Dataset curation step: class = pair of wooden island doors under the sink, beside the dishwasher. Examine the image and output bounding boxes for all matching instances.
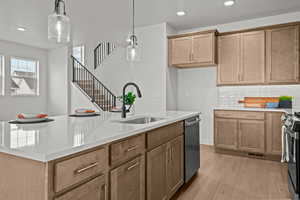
[147,136,183,200]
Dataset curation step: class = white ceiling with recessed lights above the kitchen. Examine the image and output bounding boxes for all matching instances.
[0,0,300,49]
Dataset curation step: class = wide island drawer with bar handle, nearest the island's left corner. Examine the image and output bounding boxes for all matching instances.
[54,147,108,192]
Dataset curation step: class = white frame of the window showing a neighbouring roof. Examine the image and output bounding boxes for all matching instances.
[8,56,40,97]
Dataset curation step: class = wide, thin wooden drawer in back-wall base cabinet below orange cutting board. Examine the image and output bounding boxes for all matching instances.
[215,111,265,120]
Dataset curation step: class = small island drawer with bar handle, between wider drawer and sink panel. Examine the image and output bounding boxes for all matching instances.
[110,134,145,165]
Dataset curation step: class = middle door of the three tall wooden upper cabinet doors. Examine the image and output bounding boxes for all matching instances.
[240,31,266,84]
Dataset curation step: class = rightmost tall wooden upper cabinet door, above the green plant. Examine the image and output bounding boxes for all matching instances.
[267,26,299,83]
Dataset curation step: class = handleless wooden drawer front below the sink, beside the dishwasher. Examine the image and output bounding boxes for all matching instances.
[147,122,184,149]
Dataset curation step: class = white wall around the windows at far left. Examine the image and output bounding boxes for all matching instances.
[0,40,48,120]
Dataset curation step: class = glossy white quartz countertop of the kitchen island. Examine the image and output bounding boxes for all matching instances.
[0,111,200,162]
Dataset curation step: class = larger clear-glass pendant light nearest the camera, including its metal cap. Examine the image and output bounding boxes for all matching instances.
[48,0,71,43]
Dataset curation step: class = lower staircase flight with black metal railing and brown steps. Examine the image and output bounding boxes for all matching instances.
[71,56,117,111]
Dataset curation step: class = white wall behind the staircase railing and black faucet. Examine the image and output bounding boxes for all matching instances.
[72,23,167,113]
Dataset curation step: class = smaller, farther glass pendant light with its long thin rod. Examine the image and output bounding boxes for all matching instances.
[127,0,140,62]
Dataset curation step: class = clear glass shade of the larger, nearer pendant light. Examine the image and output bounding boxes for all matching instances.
[48,12,71,43]
